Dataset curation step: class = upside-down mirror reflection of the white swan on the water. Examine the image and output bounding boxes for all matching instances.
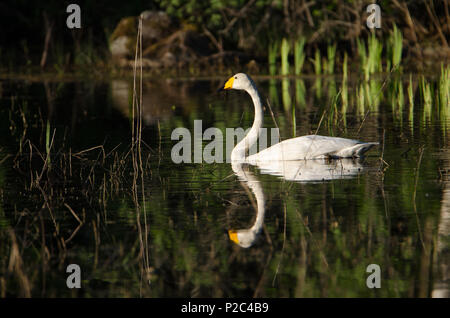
[228,159,372,248]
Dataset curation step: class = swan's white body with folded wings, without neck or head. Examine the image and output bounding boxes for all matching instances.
[248,135,377,163]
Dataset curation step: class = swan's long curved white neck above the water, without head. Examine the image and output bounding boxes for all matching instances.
[231,83,264,161]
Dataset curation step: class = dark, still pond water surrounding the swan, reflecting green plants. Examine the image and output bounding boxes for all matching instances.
[0,78,450,297]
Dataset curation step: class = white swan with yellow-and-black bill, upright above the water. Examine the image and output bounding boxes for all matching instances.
[219,73,379,165]
